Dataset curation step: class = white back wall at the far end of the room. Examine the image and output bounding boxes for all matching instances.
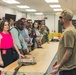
[27,14,59,32]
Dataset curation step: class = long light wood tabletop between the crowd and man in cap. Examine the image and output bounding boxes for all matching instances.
[2,42,58,75]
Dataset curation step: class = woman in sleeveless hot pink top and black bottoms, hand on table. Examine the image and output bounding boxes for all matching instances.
[0,20,24,68]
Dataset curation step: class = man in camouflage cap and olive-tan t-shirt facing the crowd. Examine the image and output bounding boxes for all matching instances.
[51,9,76,75]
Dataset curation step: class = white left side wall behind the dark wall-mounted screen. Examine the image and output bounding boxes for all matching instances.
[0,6,26,20]
